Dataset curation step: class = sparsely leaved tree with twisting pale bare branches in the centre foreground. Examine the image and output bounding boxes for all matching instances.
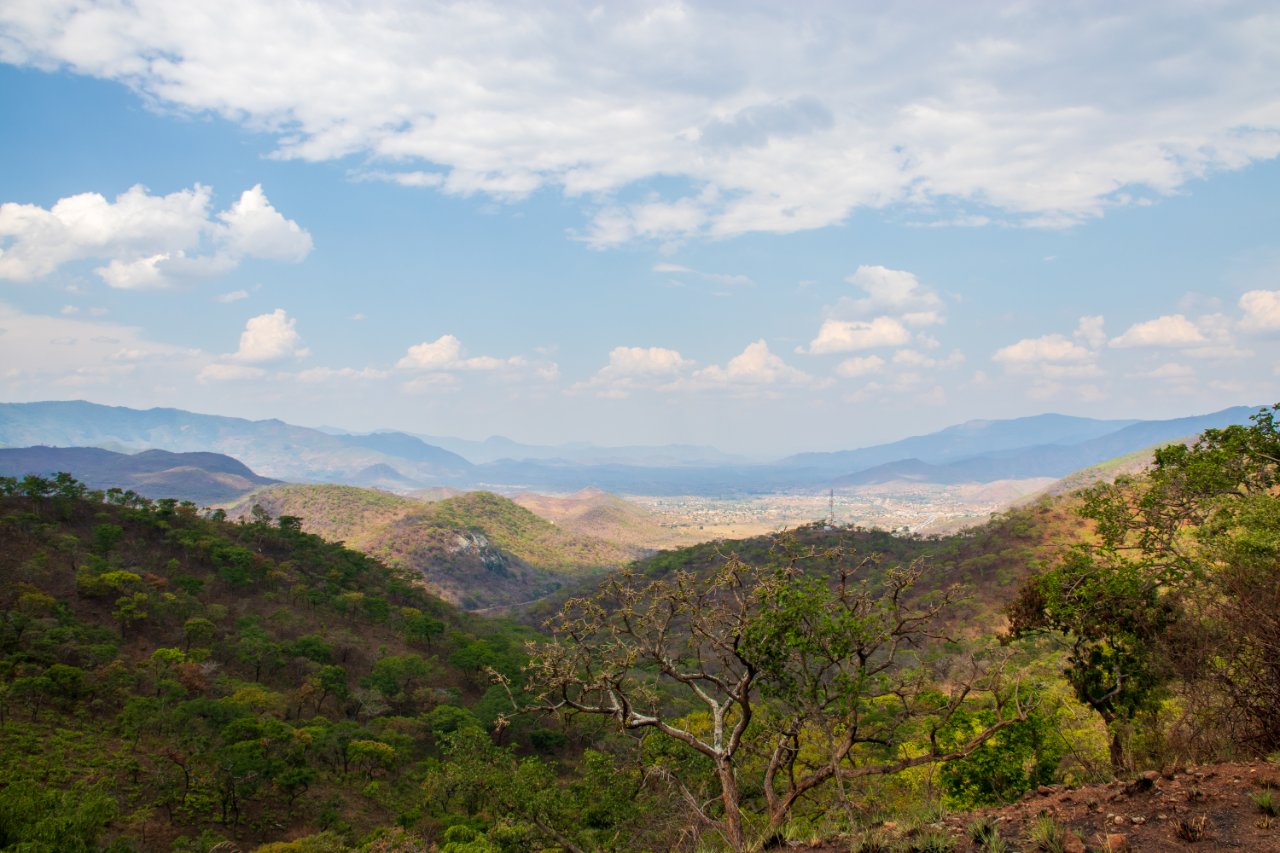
[527,552,1029,850]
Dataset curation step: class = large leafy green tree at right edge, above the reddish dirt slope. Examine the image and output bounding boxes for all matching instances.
[1010,406,1280,758]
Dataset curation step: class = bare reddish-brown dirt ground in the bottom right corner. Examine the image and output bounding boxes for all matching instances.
[817,761,1280,853]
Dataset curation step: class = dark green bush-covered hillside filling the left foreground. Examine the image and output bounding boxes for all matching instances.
[0,479,547,852]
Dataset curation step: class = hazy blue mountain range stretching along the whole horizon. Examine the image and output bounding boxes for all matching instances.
[0,401,1256,494]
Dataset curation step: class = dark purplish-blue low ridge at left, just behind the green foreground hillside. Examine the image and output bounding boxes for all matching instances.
[0,446,279,505]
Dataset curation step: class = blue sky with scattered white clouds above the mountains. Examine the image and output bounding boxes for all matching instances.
[0,0,1280,457]
